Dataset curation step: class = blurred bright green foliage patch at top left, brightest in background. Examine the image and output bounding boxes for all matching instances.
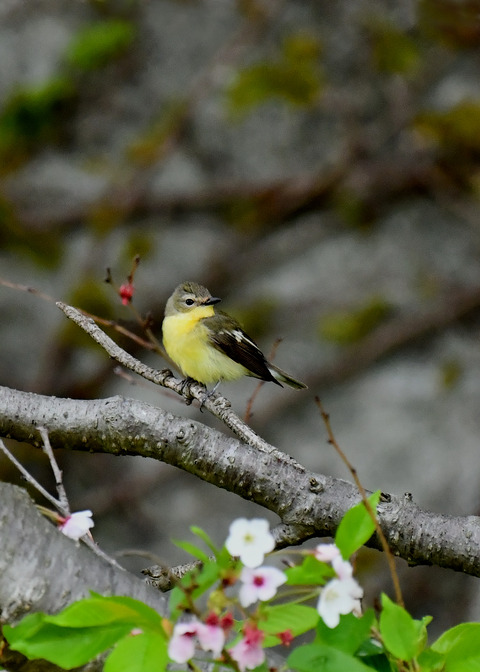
[66,19,136,72]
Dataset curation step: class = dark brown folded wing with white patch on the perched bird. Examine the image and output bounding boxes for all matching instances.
[204,313,283,387]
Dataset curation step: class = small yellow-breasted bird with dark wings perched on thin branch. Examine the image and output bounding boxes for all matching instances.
[162,282,307,393]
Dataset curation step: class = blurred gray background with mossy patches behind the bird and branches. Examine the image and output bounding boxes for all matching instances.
[0,0,480,633]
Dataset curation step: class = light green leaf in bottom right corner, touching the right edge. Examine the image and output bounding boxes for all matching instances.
[431,623,480,672]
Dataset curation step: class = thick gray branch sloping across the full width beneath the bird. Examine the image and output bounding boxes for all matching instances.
[0,388,480,576]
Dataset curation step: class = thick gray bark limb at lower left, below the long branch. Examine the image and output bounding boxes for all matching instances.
[0,483,167,623]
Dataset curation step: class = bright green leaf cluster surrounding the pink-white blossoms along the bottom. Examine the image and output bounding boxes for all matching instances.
[4,492,480,672]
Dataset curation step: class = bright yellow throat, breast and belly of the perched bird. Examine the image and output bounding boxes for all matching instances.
[163,314,248,385]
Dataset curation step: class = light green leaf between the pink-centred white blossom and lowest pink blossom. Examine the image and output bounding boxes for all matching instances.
[259,603,320,646]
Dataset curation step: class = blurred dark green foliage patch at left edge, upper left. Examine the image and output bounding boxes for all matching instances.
[0,77,76,172]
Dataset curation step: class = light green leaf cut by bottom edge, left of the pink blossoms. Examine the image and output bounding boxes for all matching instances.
[104,632,168,672]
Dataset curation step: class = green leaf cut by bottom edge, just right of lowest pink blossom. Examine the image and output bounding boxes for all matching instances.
[287,644,374,672]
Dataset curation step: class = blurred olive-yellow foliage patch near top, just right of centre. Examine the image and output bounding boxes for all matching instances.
[227,34,323,118]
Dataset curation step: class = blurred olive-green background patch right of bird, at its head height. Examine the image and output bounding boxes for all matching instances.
[319,296,392,345]
